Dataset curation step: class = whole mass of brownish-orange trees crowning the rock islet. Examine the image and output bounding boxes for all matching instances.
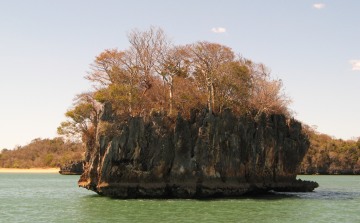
[58,27,290,143]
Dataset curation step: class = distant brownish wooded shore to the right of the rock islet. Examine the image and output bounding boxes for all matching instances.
[300,126,360,174]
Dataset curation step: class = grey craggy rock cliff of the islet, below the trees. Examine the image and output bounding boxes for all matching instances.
[79,106,318,198]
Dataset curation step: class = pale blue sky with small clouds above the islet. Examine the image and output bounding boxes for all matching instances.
[0,0,360,149]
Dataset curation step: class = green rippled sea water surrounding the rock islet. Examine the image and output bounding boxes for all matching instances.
[0,173,360,223]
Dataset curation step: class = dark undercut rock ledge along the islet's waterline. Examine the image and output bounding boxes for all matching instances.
[79,181,319,199]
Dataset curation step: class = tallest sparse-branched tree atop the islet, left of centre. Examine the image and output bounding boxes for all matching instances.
[86,27,169,116]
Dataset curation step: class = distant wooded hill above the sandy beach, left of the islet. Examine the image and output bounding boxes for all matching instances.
[0,138,84,168]
